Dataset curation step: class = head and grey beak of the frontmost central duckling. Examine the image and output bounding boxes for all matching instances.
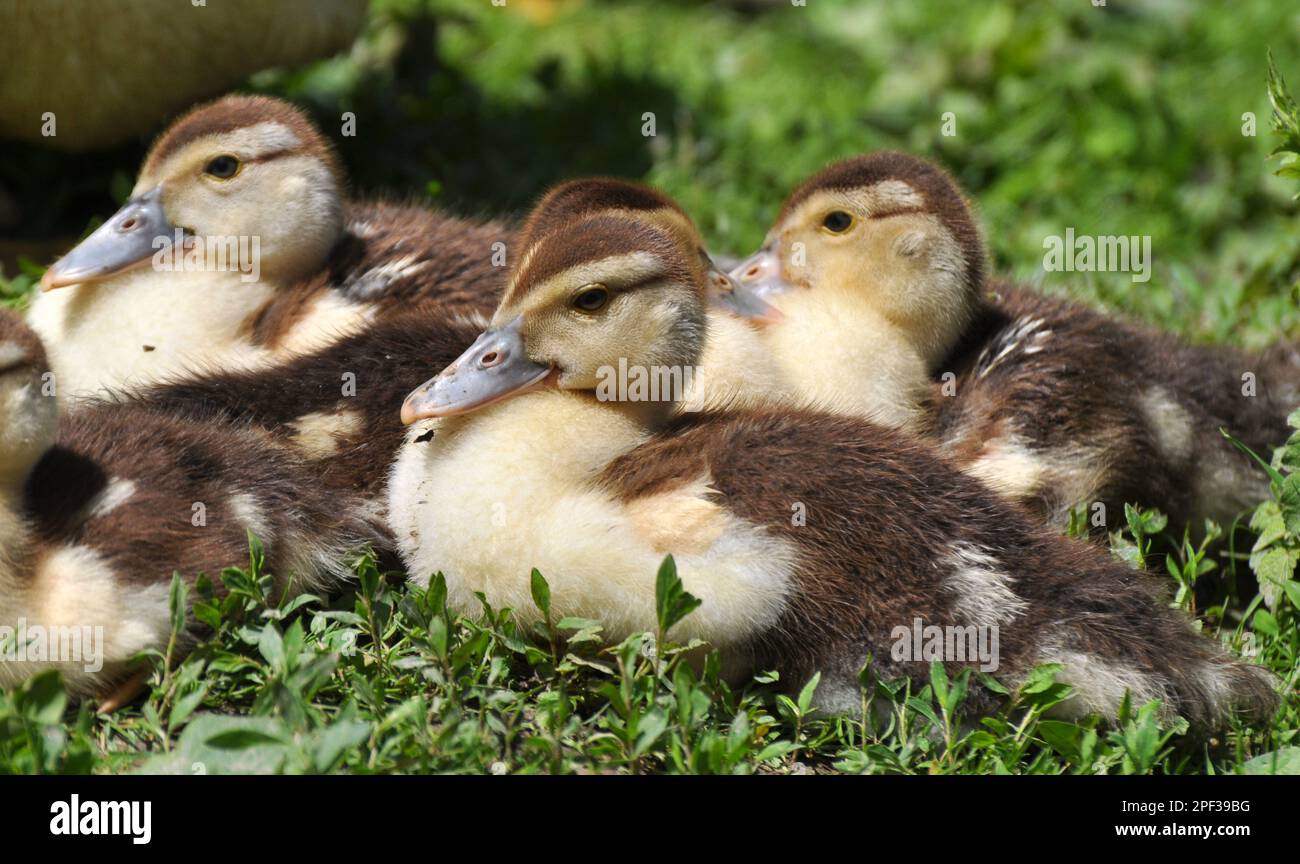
[402,200,707,424]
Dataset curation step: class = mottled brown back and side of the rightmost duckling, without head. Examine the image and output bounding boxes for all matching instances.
[931,285,1287,529]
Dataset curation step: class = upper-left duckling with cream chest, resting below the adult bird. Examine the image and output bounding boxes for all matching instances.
[29,96,508,398]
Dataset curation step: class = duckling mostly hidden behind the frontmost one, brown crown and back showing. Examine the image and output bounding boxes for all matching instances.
[127,178,785,548]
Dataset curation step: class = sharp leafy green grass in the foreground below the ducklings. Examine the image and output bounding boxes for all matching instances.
[0,547,1300,774]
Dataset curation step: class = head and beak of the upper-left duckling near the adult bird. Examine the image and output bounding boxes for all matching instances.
[42,96,345,291]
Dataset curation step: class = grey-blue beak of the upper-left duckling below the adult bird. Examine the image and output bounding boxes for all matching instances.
[40,183,177,291]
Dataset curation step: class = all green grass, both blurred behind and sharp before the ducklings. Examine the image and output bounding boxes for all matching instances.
[0,0,1300,773]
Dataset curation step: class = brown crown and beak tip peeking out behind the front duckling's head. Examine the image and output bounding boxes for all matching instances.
[520,177,780,322]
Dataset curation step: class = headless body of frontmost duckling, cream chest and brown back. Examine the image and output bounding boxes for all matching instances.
[389,392,1275,729]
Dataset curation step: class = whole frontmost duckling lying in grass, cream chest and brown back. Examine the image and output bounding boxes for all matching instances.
[389,198,1275,728]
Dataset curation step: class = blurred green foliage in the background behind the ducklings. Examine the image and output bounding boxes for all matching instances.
[0,0,1300,346]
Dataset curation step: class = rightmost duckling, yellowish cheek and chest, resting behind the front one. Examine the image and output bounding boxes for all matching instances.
[732,152,1294,530]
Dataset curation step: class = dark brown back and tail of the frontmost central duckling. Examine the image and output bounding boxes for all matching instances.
[602,412,1277,729]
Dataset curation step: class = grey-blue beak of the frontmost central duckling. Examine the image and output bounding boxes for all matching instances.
[402,318,554,426]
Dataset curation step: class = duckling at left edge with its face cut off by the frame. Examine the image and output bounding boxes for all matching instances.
[0,311,381,696]
